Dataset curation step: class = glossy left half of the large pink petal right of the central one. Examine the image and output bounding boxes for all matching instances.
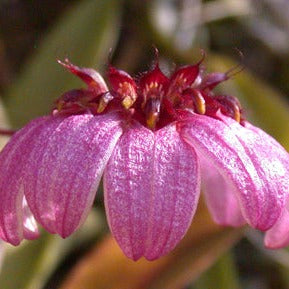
[179,114,264,229]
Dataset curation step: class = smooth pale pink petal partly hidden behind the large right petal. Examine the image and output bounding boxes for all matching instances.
[201,154,246,227]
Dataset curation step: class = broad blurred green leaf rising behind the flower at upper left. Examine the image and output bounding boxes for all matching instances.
[5,0,120,127]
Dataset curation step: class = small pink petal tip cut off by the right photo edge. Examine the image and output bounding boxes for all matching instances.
[264,209,289,249]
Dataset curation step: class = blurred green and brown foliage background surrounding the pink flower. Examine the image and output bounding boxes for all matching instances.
[0,0,289,289]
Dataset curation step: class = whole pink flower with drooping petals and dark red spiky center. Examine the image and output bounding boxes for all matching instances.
[0,50,289,260]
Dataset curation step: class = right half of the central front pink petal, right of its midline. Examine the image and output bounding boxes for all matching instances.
[144,125,200,260]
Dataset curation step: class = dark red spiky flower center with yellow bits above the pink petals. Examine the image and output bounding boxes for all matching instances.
[54,53,243,130]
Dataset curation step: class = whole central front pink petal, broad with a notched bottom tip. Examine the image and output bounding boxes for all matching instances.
[104,125,200,260]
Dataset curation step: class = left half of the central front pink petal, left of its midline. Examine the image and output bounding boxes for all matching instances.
[103,125,154,260]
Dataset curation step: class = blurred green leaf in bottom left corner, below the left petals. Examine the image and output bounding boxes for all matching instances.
[0,210,103,289]
